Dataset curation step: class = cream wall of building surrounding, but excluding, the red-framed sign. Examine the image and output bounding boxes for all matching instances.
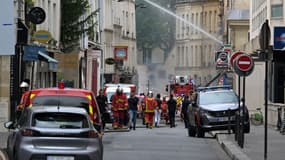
[102,0,137,82]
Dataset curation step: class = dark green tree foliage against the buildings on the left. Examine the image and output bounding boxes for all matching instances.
[60,0,98,52]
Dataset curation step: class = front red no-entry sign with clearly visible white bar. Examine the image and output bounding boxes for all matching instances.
[236,54,253,72]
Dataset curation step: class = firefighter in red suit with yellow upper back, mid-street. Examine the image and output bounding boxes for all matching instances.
[145,92,157,129]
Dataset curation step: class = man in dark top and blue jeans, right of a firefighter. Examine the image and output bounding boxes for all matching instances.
[128,92,139,130]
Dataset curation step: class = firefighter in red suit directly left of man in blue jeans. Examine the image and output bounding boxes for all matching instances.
[112,88,128,129]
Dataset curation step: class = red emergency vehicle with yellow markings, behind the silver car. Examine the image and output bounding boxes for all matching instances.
[17,84,102,131]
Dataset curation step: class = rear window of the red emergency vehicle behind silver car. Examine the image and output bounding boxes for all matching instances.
[32,96,89,109]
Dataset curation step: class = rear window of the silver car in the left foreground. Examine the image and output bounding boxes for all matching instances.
[32,112,89,129]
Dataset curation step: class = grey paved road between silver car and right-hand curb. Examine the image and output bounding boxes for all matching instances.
[103,122,229,160]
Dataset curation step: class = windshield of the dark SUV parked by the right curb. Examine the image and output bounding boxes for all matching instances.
[199,92,238,105]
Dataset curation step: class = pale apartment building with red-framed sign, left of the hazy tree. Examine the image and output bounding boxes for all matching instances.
[100,0,137,83]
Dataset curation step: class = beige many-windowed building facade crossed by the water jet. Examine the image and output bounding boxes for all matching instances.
[175,0,222,85]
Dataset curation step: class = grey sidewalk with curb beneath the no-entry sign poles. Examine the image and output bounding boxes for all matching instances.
[216,125,285,160]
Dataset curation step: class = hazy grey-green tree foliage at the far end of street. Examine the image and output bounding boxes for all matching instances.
[136,0,175,55]
